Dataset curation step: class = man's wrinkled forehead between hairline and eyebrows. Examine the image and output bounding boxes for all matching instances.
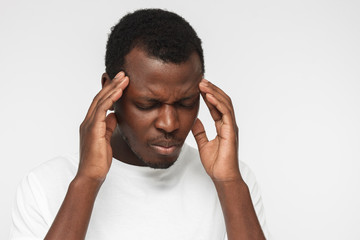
[124,48,203,101]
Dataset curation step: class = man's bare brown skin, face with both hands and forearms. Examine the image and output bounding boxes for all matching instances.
[45,48,265,240]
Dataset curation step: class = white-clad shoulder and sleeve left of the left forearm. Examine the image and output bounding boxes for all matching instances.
[12,155,77,232]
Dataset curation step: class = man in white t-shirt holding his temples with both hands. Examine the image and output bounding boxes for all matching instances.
[11,9,265,240]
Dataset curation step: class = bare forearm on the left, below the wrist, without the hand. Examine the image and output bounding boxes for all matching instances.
[45,175,102,240]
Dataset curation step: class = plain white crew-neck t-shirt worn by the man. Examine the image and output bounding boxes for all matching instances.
[10,145,267,240]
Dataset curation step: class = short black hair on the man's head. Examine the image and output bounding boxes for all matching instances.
[105,9,205,79]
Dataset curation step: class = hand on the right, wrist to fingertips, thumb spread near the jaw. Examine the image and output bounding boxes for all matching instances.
[192,79,242,181]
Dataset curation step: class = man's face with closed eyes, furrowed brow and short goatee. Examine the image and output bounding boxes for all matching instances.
[115,48,203,168]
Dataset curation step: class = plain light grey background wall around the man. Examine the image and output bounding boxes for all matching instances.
[0,0,360,240]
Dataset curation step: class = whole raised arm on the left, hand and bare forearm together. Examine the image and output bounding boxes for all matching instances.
[45,72,129,240]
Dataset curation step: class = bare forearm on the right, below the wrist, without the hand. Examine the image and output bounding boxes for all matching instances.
[214,179,265,240]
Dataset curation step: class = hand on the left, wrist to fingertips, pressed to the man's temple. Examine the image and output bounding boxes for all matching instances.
[76,72,129,183]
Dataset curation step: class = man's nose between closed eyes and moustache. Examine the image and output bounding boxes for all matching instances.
[155,104,180,133]
